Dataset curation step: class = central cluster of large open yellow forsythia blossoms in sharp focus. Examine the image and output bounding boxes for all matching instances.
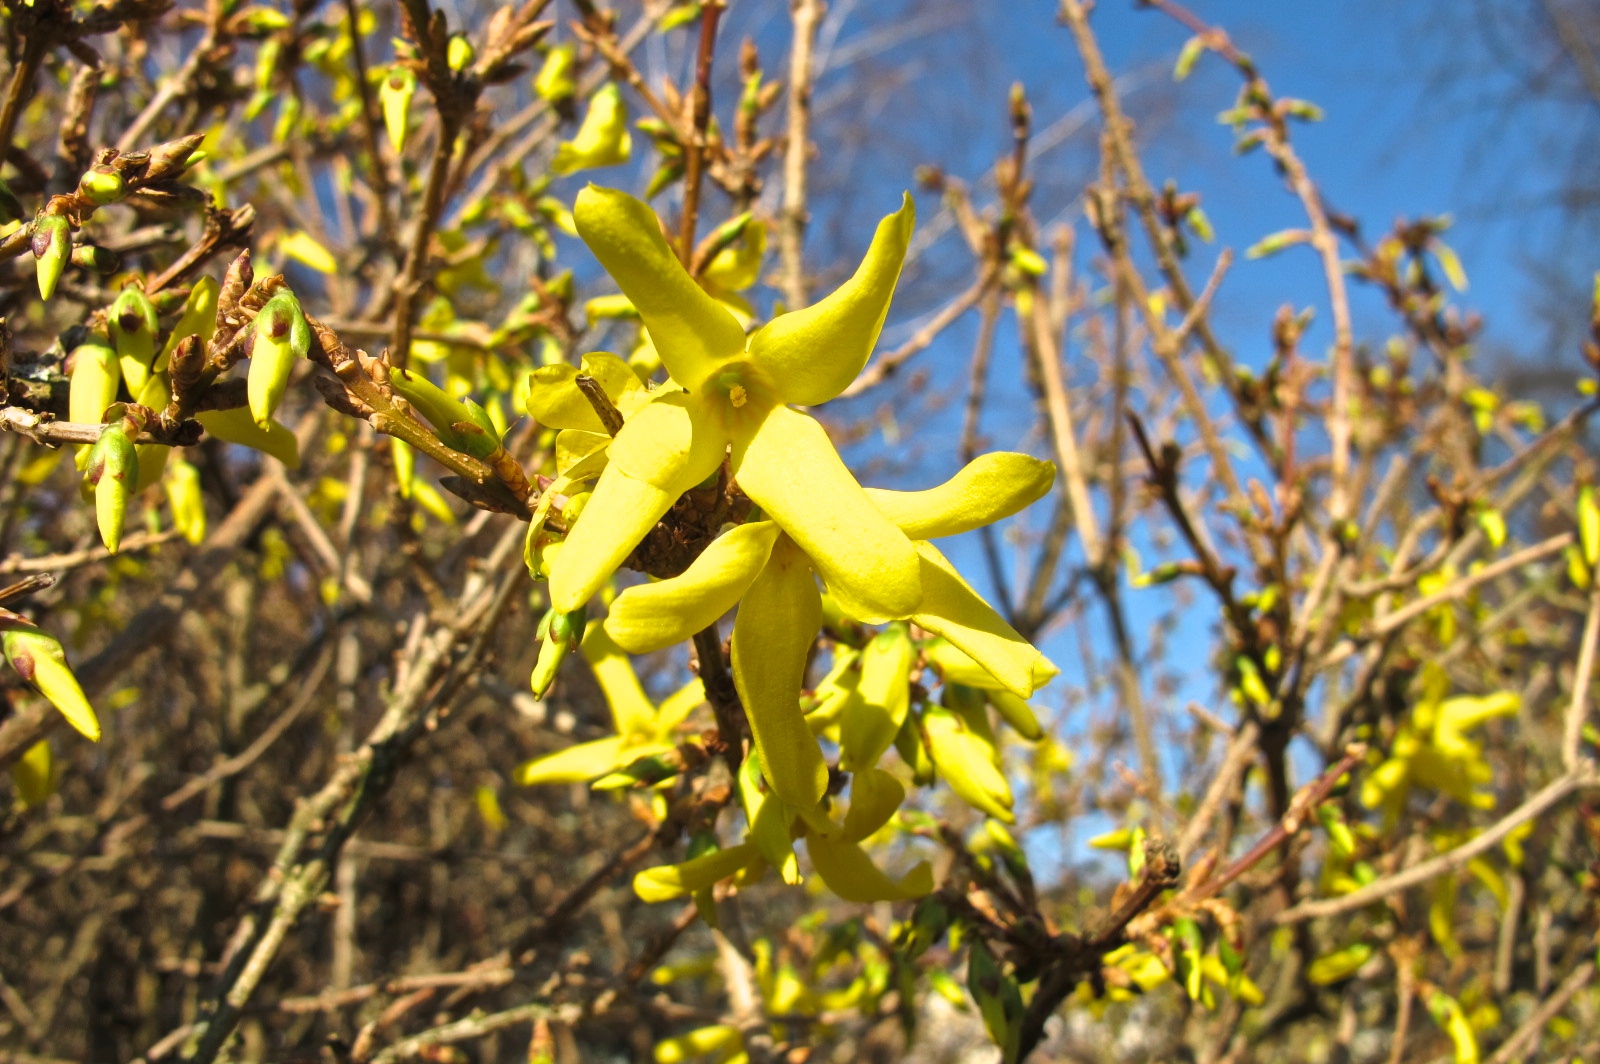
[528,186,1056,899]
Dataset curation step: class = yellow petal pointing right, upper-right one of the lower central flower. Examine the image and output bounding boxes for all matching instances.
[866,451,1056,539]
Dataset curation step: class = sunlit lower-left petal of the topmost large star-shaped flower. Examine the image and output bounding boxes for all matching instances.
[550,392,726,613]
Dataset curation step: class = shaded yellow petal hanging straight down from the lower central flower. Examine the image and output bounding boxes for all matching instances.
[733,539,827,810]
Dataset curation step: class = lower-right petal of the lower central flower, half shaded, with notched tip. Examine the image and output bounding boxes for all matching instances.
[912,542,1056,698]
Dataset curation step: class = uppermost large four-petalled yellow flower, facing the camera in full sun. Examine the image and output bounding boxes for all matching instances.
[550,186,925,630]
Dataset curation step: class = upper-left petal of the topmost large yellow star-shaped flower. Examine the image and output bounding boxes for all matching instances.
[573,186,744,392]
